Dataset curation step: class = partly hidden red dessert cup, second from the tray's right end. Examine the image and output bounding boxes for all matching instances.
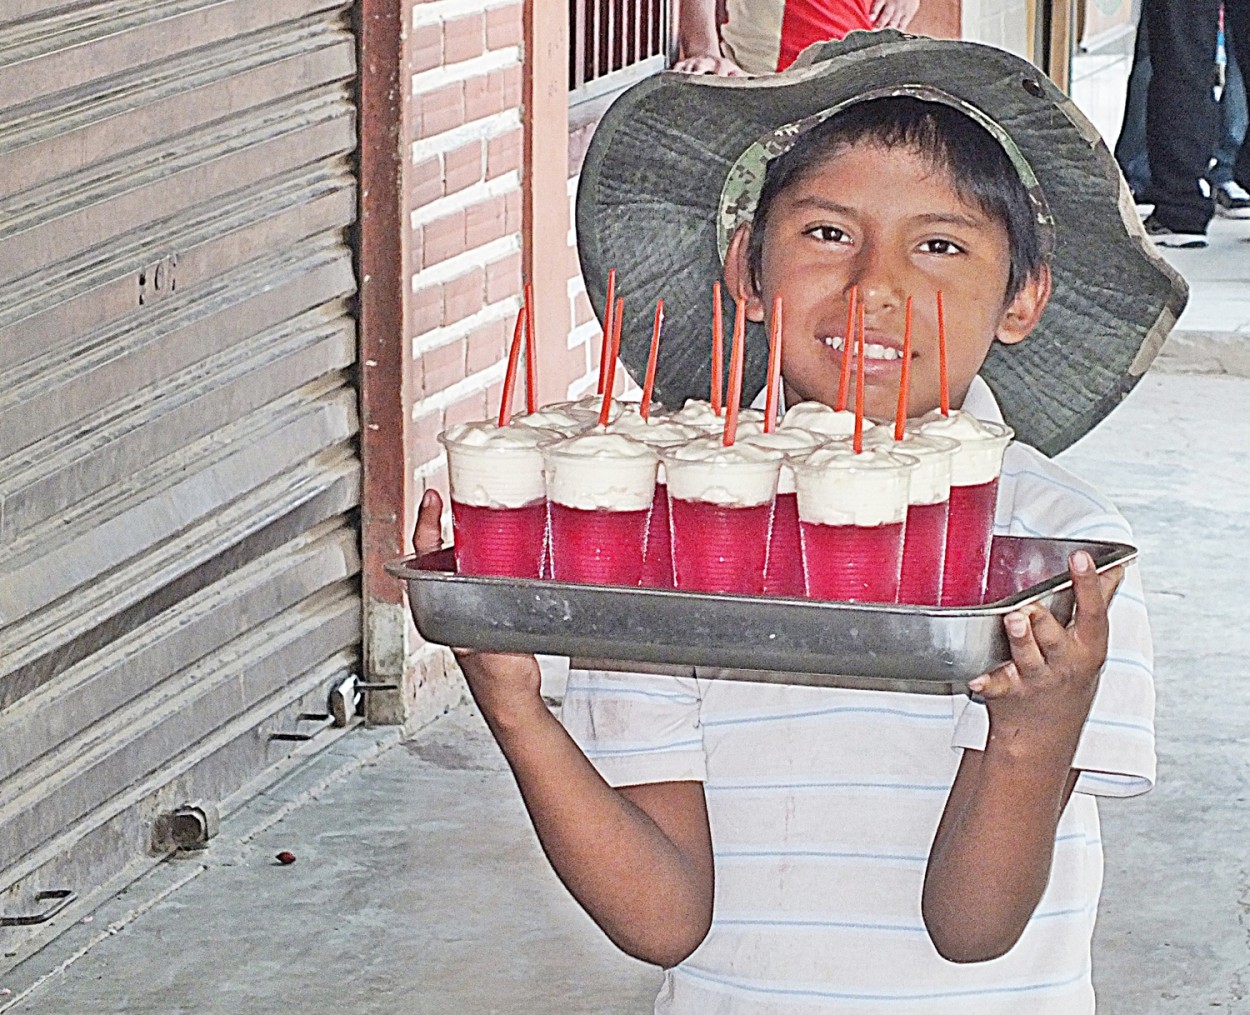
[864,426,959,606]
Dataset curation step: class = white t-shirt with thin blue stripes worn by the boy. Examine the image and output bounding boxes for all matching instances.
[564,381,1155,1015]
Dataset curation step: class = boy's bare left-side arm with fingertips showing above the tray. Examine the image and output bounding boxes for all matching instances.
[413,493,713,968]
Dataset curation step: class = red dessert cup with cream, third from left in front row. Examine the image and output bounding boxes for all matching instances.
[661,435,781,595]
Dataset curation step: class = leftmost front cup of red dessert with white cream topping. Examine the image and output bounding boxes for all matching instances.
[439,421,555,578]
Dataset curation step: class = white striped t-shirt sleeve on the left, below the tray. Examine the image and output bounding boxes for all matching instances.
[560,670,708,786]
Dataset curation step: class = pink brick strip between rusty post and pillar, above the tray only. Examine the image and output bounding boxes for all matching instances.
[408,0,524,515]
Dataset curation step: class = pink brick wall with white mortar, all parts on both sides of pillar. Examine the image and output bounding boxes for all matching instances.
[390,0,615,724]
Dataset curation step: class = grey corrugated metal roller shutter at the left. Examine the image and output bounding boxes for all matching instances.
[0,0,361,950]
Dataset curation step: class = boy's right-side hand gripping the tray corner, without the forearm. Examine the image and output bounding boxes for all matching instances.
[968,551,1124,744]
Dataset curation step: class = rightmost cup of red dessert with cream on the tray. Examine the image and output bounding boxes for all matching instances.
[916,410,1014,606]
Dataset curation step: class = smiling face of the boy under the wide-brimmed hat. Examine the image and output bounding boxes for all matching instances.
[725,145,1050,418]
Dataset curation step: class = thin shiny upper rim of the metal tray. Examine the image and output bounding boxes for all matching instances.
[383,535,1139,619]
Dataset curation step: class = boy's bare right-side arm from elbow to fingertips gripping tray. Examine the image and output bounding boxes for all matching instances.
[923,554,1121,963]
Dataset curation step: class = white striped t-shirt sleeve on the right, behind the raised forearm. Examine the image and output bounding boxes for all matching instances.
[954,516,1155,796]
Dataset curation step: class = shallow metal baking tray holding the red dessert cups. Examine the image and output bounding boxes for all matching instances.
[386,536,1138,686]
